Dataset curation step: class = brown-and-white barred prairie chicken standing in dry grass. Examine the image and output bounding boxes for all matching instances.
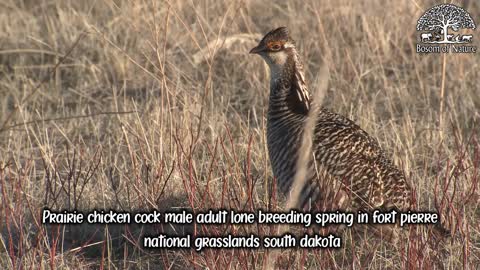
[250,27,412,211]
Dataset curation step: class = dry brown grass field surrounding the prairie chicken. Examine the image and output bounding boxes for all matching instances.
[0,0,480,269]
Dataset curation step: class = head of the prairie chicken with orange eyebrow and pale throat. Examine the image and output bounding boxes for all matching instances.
[250,27,295,70]
